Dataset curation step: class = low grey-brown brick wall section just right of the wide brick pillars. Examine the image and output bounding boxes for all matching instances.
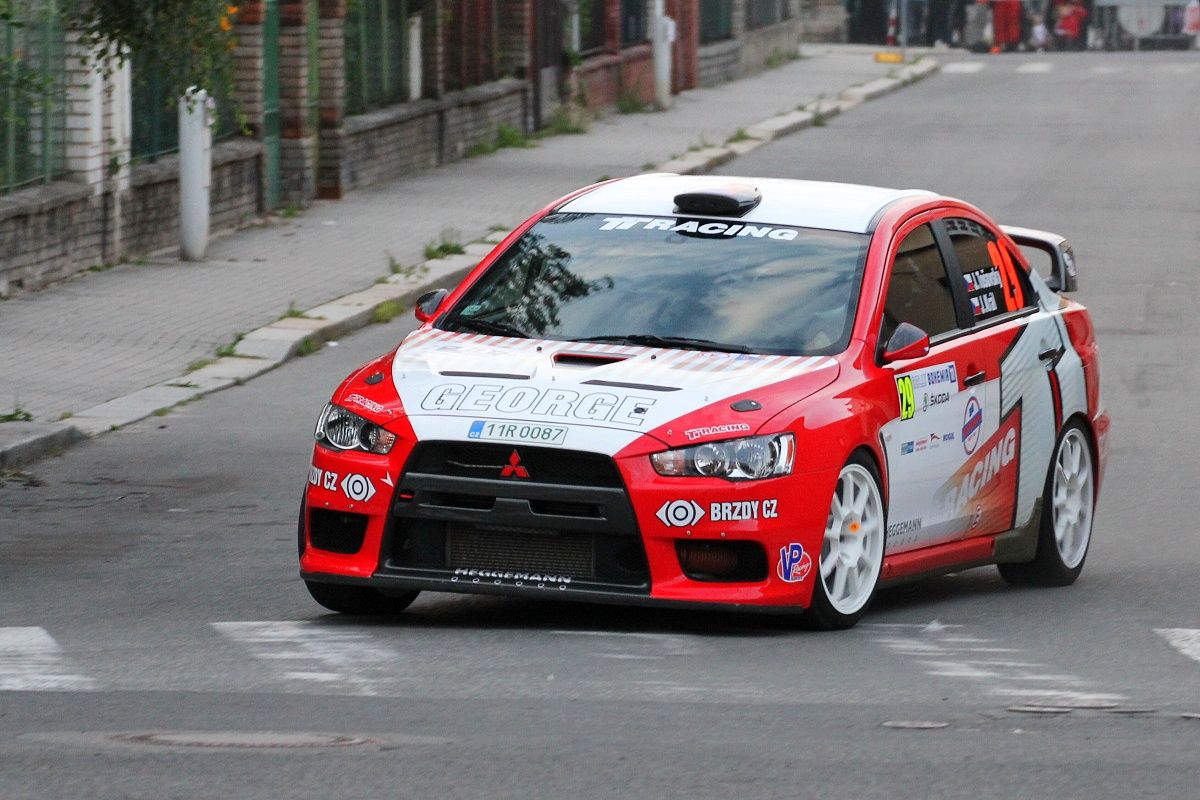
[338,78,529,191]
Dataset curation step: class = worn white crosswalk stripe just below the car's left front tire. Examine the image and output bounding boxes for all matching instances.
[211,621,403,696]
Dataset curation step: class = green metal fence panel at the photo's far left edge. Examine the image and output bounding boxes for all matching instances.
[0,0,67,194]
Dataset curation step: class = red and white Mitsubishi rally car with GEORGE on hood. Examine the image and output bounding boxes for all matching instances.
[299,175,1109,628]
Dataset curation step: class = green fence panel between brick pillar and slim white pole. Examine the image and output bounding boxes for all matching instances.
[346,0,409,114]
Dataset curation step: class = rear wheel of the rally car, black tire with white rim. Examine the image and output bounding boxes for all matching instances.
[996,422,1096,587]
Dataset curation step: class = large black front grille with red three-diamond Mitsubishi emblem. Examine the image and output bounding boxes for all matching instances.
[379,443,649,594]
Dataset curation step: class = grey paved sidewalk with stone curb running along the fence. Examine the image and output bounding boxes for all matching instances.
[0,44,936,468]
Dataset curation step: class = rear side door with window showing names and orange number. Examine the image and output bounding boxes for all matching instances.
[937,216,1063,536]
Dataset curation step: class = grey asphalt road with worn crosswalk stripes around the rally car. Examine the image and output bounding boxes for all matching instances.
[0,53,1200,800]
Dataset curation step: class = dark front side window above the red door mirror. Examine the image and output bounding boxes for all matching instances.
[880,225,958,342]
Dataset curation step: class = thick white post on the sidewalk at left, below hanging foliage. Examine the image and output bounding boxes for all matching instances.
[179,86,214,261]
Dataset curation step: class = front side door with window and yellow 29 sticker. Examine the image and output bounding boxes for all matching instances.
[880,222,986,553]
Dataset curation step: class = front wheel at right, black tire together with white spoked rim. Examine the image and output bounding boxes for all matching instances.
[804,453,887,631]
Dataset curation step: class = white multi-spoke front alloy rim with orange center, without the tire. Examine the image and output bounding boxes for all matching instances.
[818,462,886,615]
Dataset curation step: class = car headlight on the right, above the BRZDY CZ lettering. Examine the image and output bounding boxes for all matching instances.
[650,433,796,481]
